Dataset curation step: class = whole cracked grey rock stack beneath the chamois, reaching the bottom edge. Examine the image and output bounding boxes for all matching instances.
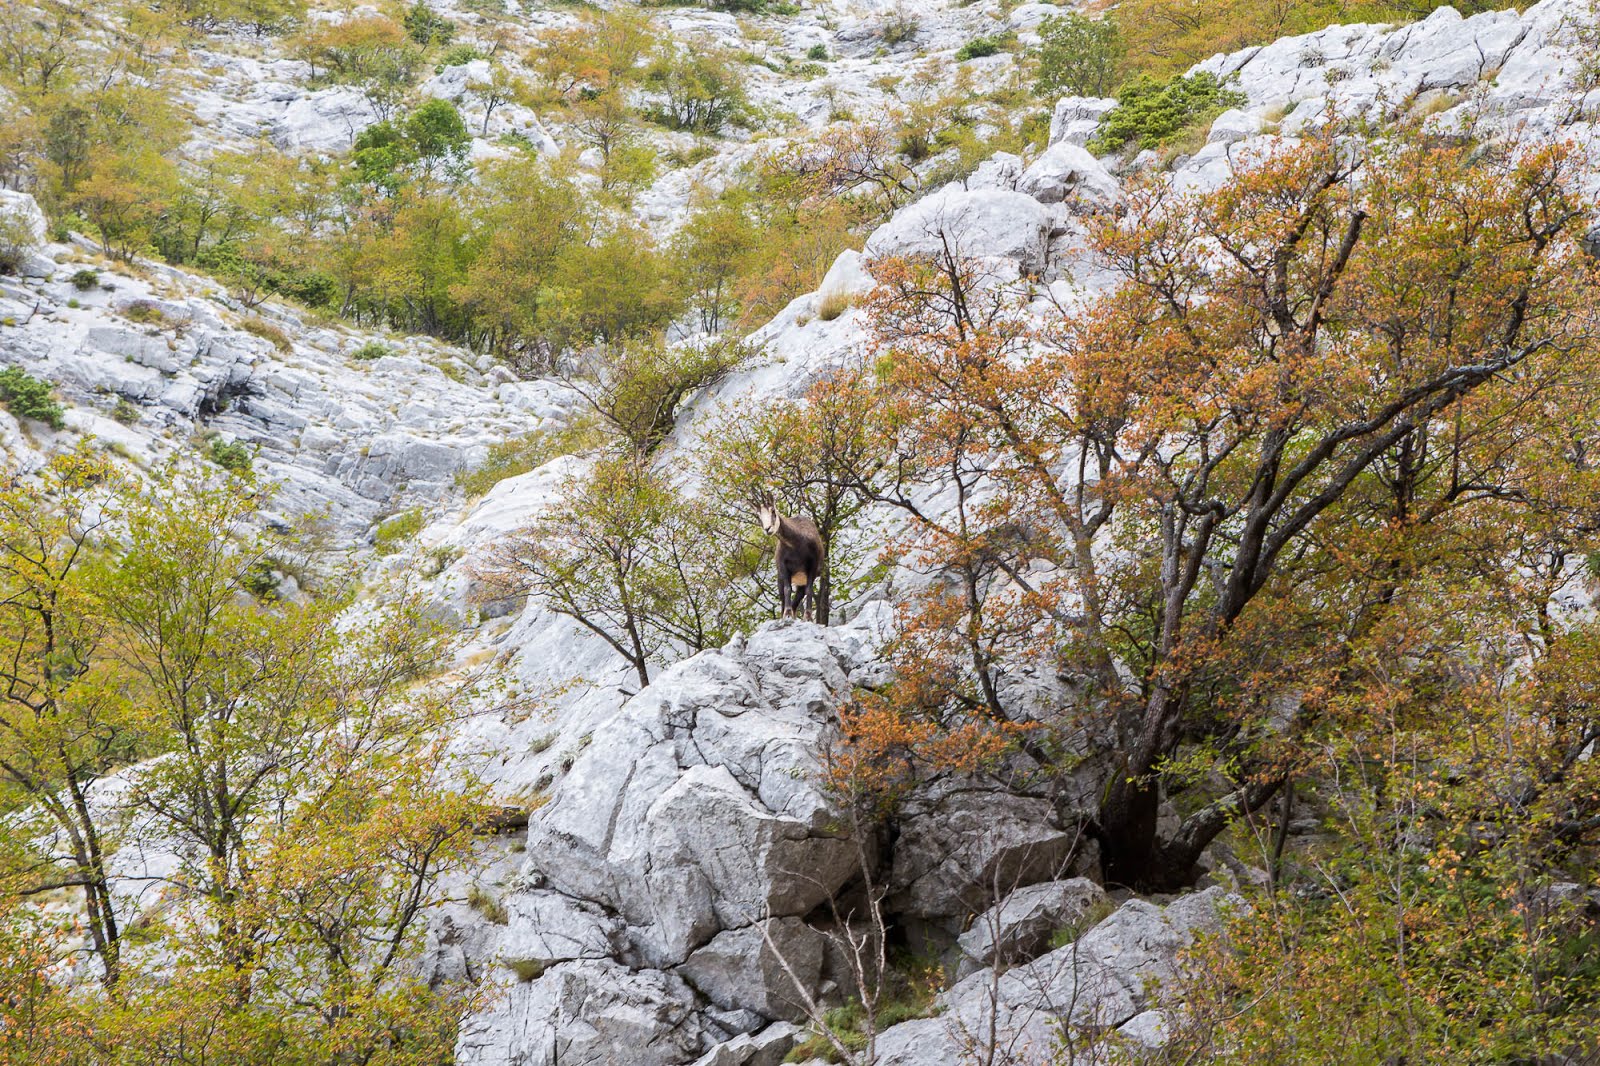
[459,603,890,1066]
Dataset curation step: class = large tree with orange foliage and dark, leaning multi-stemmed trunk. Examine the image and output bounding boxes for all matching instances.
[844,128,1597,888]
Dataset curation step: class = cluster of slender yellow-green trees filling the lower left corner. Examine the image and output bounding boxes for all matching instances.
[0,453,482,1066]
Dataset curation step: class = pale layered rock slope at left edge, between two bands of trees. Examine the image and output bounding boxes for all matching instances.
[0,228,574,541]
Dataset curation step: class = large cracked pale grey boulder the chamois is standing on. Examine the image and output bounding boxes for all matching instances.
[525,607,888,967]
